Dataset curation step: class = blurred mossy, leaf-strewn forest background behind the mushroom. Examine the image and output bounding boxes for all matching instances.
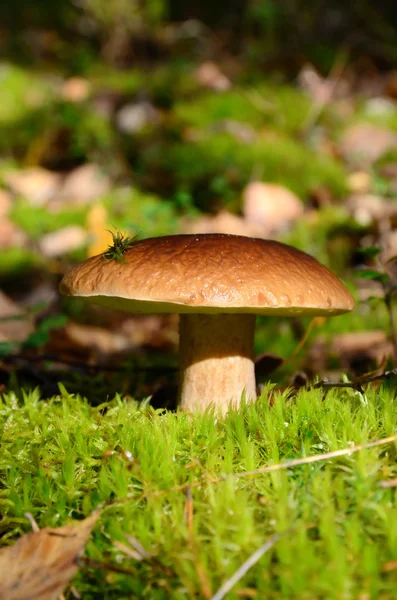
[0,0,397,404]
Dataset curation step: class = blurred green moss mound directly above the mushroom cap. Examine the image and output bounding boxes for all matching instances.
[139,132,345,210]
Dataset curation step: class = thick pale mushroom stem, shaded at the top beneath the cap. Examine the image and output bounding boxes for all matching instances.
[179,313,256,413]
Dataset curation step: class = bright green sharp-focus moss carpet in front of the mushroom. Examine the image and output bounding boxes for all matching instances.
[0,385,397,599]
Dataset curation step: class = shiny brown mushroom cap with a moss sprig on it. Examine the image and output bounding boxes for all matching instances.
[60,234,354,315]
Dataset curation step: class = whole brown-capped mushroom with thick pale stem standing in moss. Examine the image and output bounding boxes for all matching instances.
[60,234,354,412]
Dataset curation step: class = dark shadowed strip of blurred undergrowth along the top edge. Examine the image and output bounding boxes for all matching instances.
[0,0,397,72]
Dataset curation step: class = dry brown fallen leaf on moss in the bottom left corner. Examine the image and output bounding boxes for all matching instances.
[0,513,99,600]
